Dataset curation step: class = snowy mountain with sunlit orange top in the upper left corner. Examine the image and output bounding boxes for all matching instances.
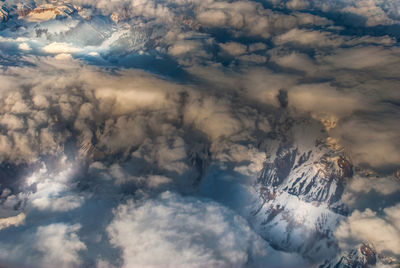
[0,1,159,56]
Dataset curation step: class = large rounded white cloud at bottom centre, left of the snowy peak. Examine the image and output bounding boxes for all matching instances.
[107,192,304,267]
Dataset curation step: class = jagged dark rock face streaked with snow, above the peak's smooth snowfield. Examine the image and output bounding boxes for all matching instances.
[258,144,352,205]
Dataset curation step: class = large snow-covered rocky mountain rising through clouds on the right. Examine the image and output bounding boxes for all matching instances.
[251,120,353,261]
